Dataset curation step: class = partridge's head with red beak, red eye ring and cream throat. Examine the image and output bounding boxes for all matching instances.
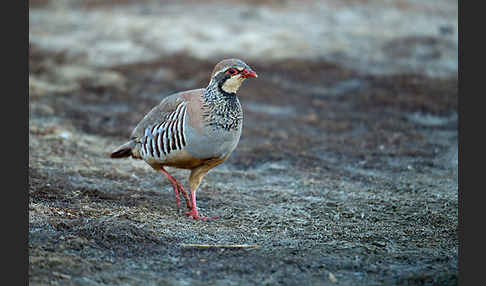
[210,59,258,93]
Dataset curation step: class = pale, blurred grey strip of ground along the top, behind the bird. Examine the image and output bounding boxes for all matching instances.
[29,0,458,76]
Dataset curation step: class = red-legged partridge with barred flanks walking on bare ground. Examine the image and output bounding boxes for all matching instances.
[110,58,258,221]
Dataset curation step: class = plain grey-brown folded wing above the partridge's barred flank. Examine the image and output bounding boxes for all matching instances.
[131,89,202,139]
